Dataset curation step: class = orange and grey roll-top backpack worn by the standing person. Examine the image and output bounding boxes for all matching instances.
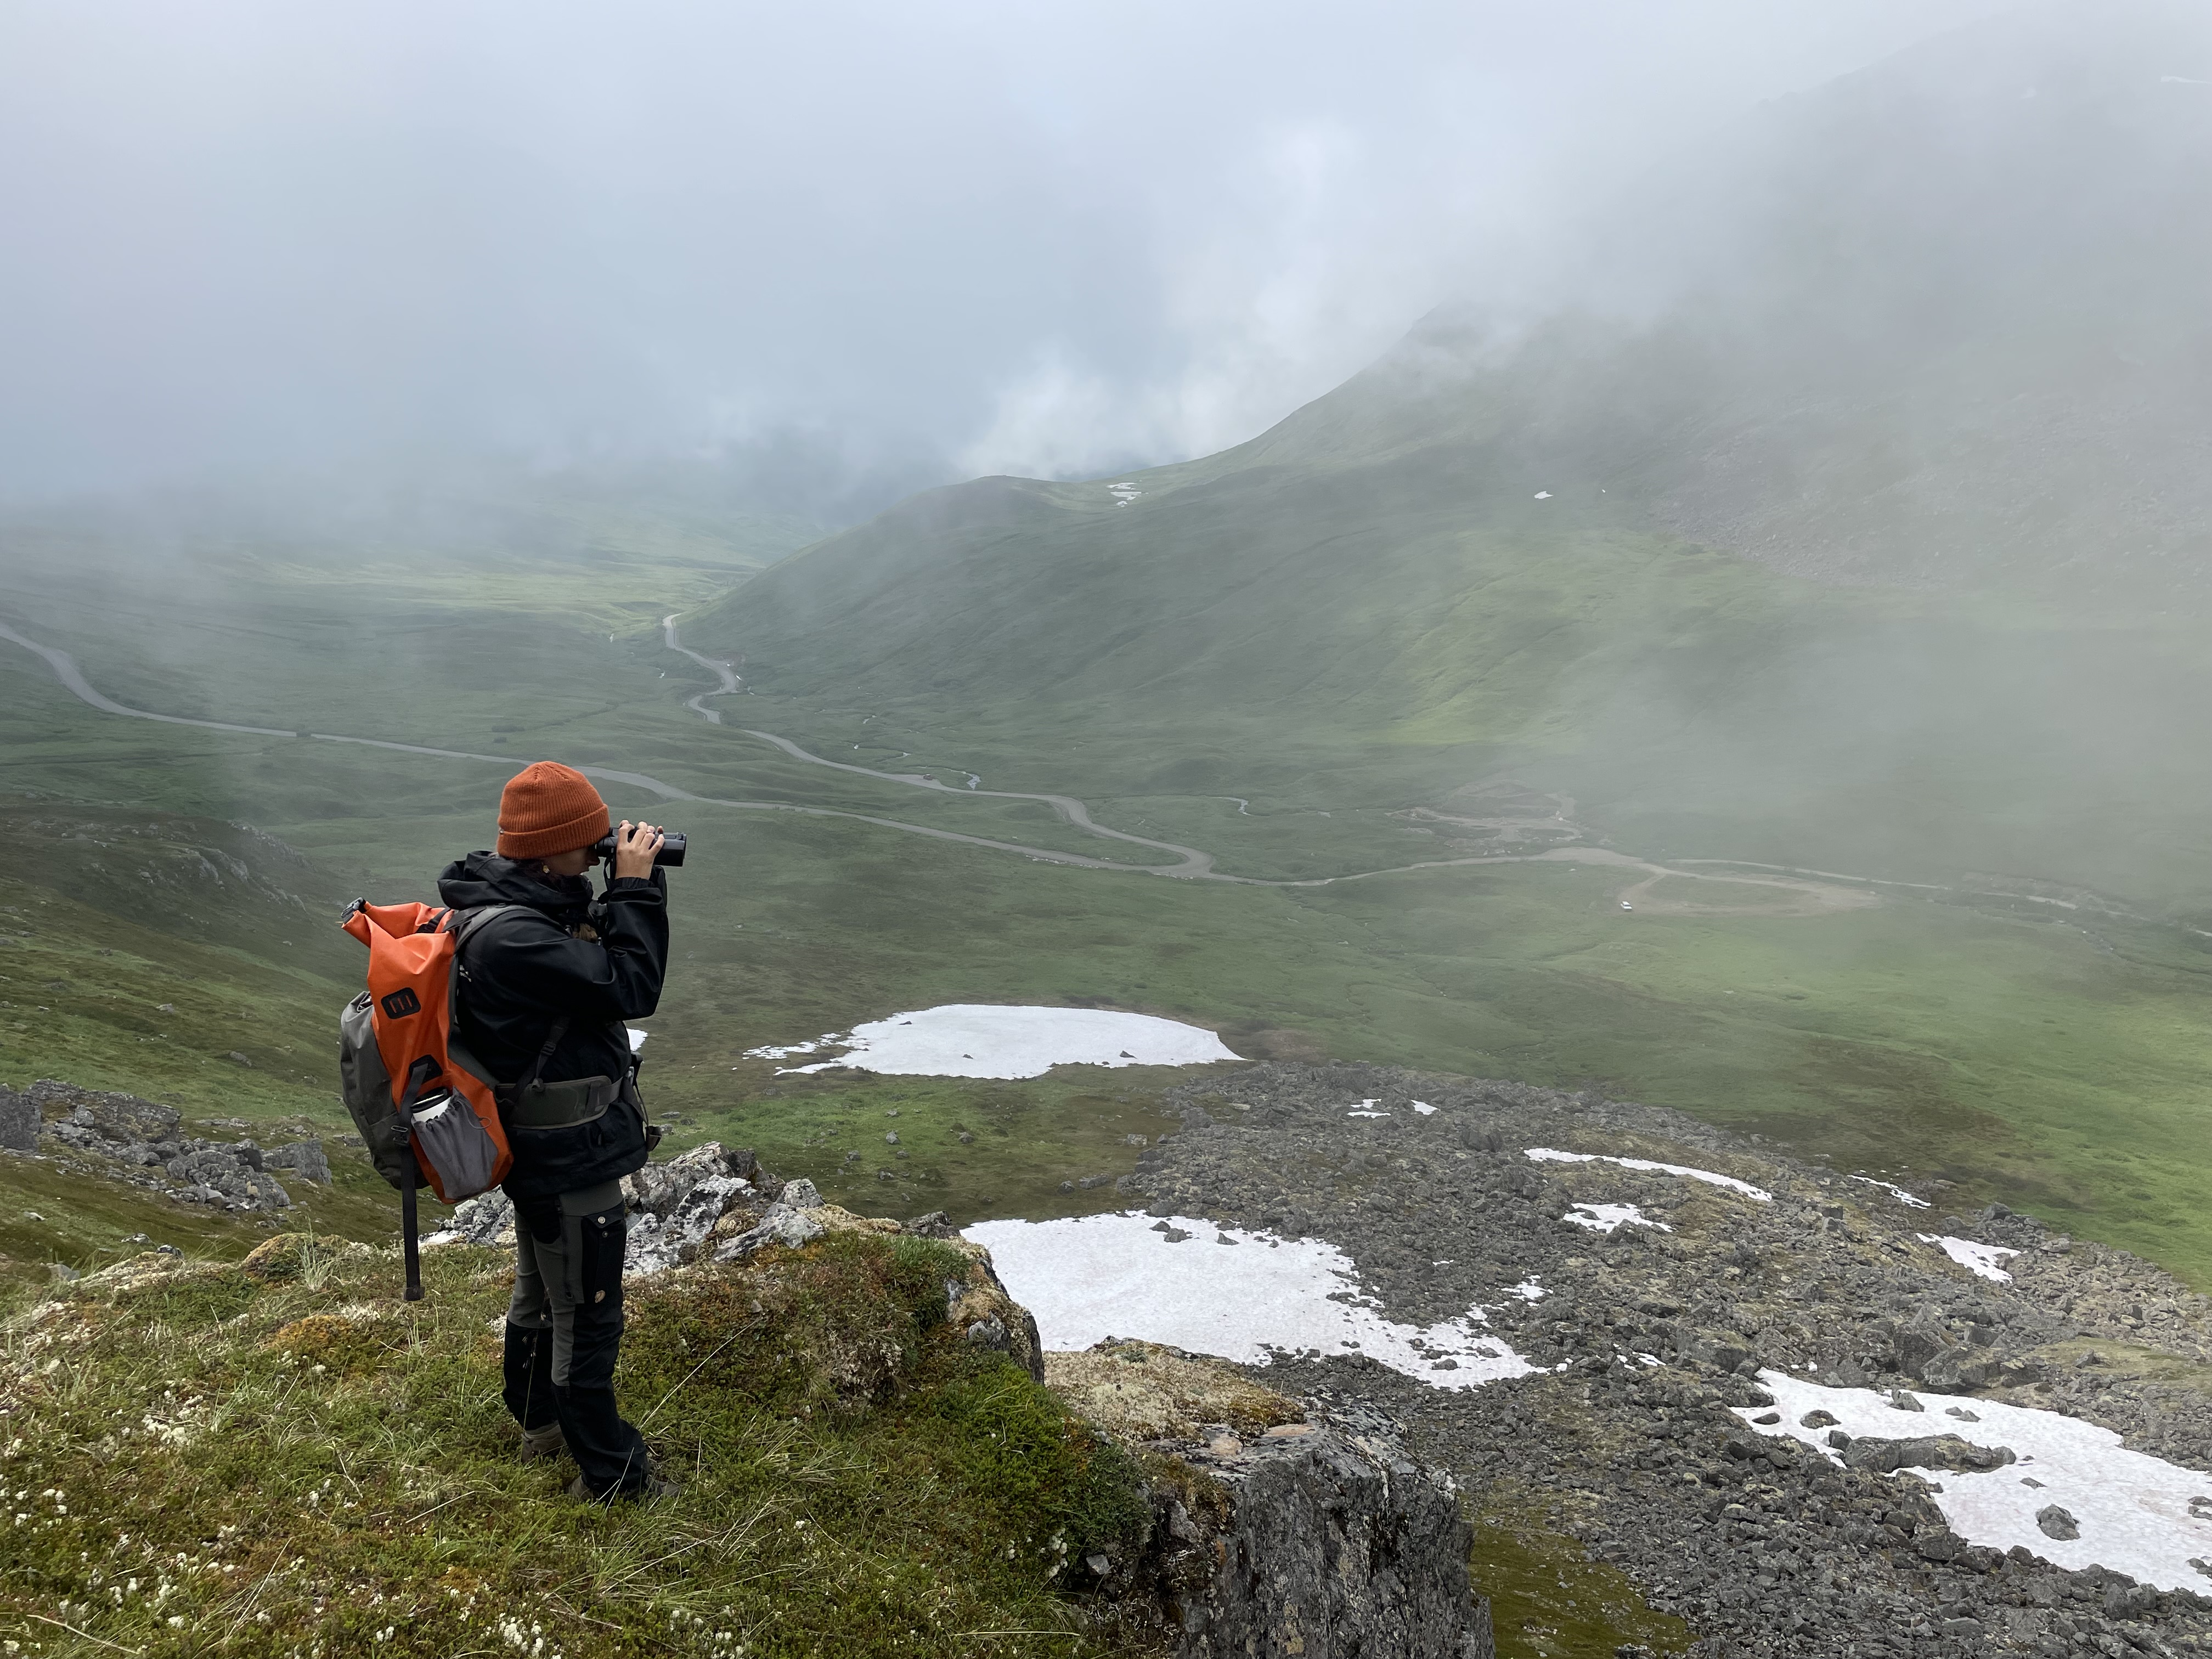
[338,898,522,1301]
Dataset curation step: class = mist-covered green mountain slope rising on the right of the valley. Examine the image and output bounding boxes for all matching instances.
[686,7,2212,911]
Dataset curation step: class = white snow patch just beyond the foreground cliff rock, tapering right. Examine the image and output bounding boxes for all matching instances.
[960,1215,1537,1389]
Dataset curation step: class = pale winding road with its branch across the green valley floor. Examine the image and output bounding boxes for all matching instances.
[0,613,2106,916]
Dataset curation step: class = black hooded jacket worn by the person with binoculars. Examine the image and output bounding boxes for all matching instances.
[438,851,668,1205]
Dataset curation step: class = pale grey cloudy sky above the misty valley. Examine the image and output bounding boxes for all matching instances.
[0,0,1993,498]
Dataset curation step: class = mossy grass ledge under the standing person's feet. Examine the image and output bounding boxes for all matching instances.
[0,1234,1144,1659]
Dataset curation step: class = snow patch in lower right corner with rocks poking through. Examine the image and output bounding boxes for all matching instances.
[1734,1372,2212,1590]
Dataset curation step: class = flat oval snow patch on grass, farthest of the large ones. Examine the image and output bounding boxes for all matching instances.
[746,1002,1241,1077]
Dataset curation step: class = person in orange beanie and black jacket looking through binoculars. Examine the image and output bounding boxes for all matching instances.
[438,761,677,1504]
